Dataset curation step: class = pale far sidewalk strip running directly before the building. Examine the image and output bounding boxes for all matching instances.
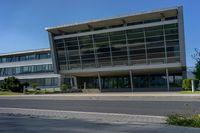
[0,92,200,101]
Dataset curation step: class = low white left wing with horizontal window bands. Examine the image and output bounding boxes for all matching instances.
[0,49,60,87]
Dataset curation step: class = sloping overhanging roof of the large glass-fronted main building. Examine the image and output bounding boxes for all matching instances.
[45,6,182,34]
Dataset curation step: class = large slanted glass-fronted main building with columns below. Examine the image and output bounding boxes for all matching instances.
[46,7,186,92]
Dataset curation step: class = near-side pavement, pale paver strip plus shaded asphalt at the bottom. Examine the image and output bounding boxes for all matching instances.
[0,108,200,133]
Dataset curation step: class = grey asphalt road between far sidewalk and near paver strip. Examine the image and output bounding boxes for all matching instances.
[0,98,200,116]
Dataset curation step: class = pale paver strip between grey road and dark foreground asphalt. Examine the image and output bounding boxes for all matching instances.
[0,108,167,124]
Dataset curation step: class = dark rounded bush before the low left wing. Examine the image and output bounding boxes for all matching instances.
[1,76,24,92]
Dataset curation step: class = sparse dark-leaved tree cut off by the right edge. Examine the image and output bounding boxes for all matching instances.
[192,48,200,80]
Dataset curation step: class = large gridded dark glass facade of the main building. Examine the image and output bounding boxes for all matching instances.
[55,23,180,70]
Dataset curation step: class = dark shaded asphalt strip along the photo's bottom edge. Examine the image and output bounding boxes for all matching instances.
[0,114,200,133]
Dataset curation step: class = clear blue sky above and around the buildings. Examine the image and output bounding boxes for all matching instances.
[0,0,200,66]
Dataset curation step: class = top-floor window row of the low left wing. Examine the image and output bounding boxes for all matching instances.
[0,53,51,63]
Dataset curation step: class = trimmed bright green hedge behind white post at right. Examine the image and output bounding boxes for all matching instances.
[182,78,199,91]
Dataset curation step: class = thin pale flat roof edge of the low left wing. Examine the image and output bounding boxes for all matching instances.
[0,48,50,56]
